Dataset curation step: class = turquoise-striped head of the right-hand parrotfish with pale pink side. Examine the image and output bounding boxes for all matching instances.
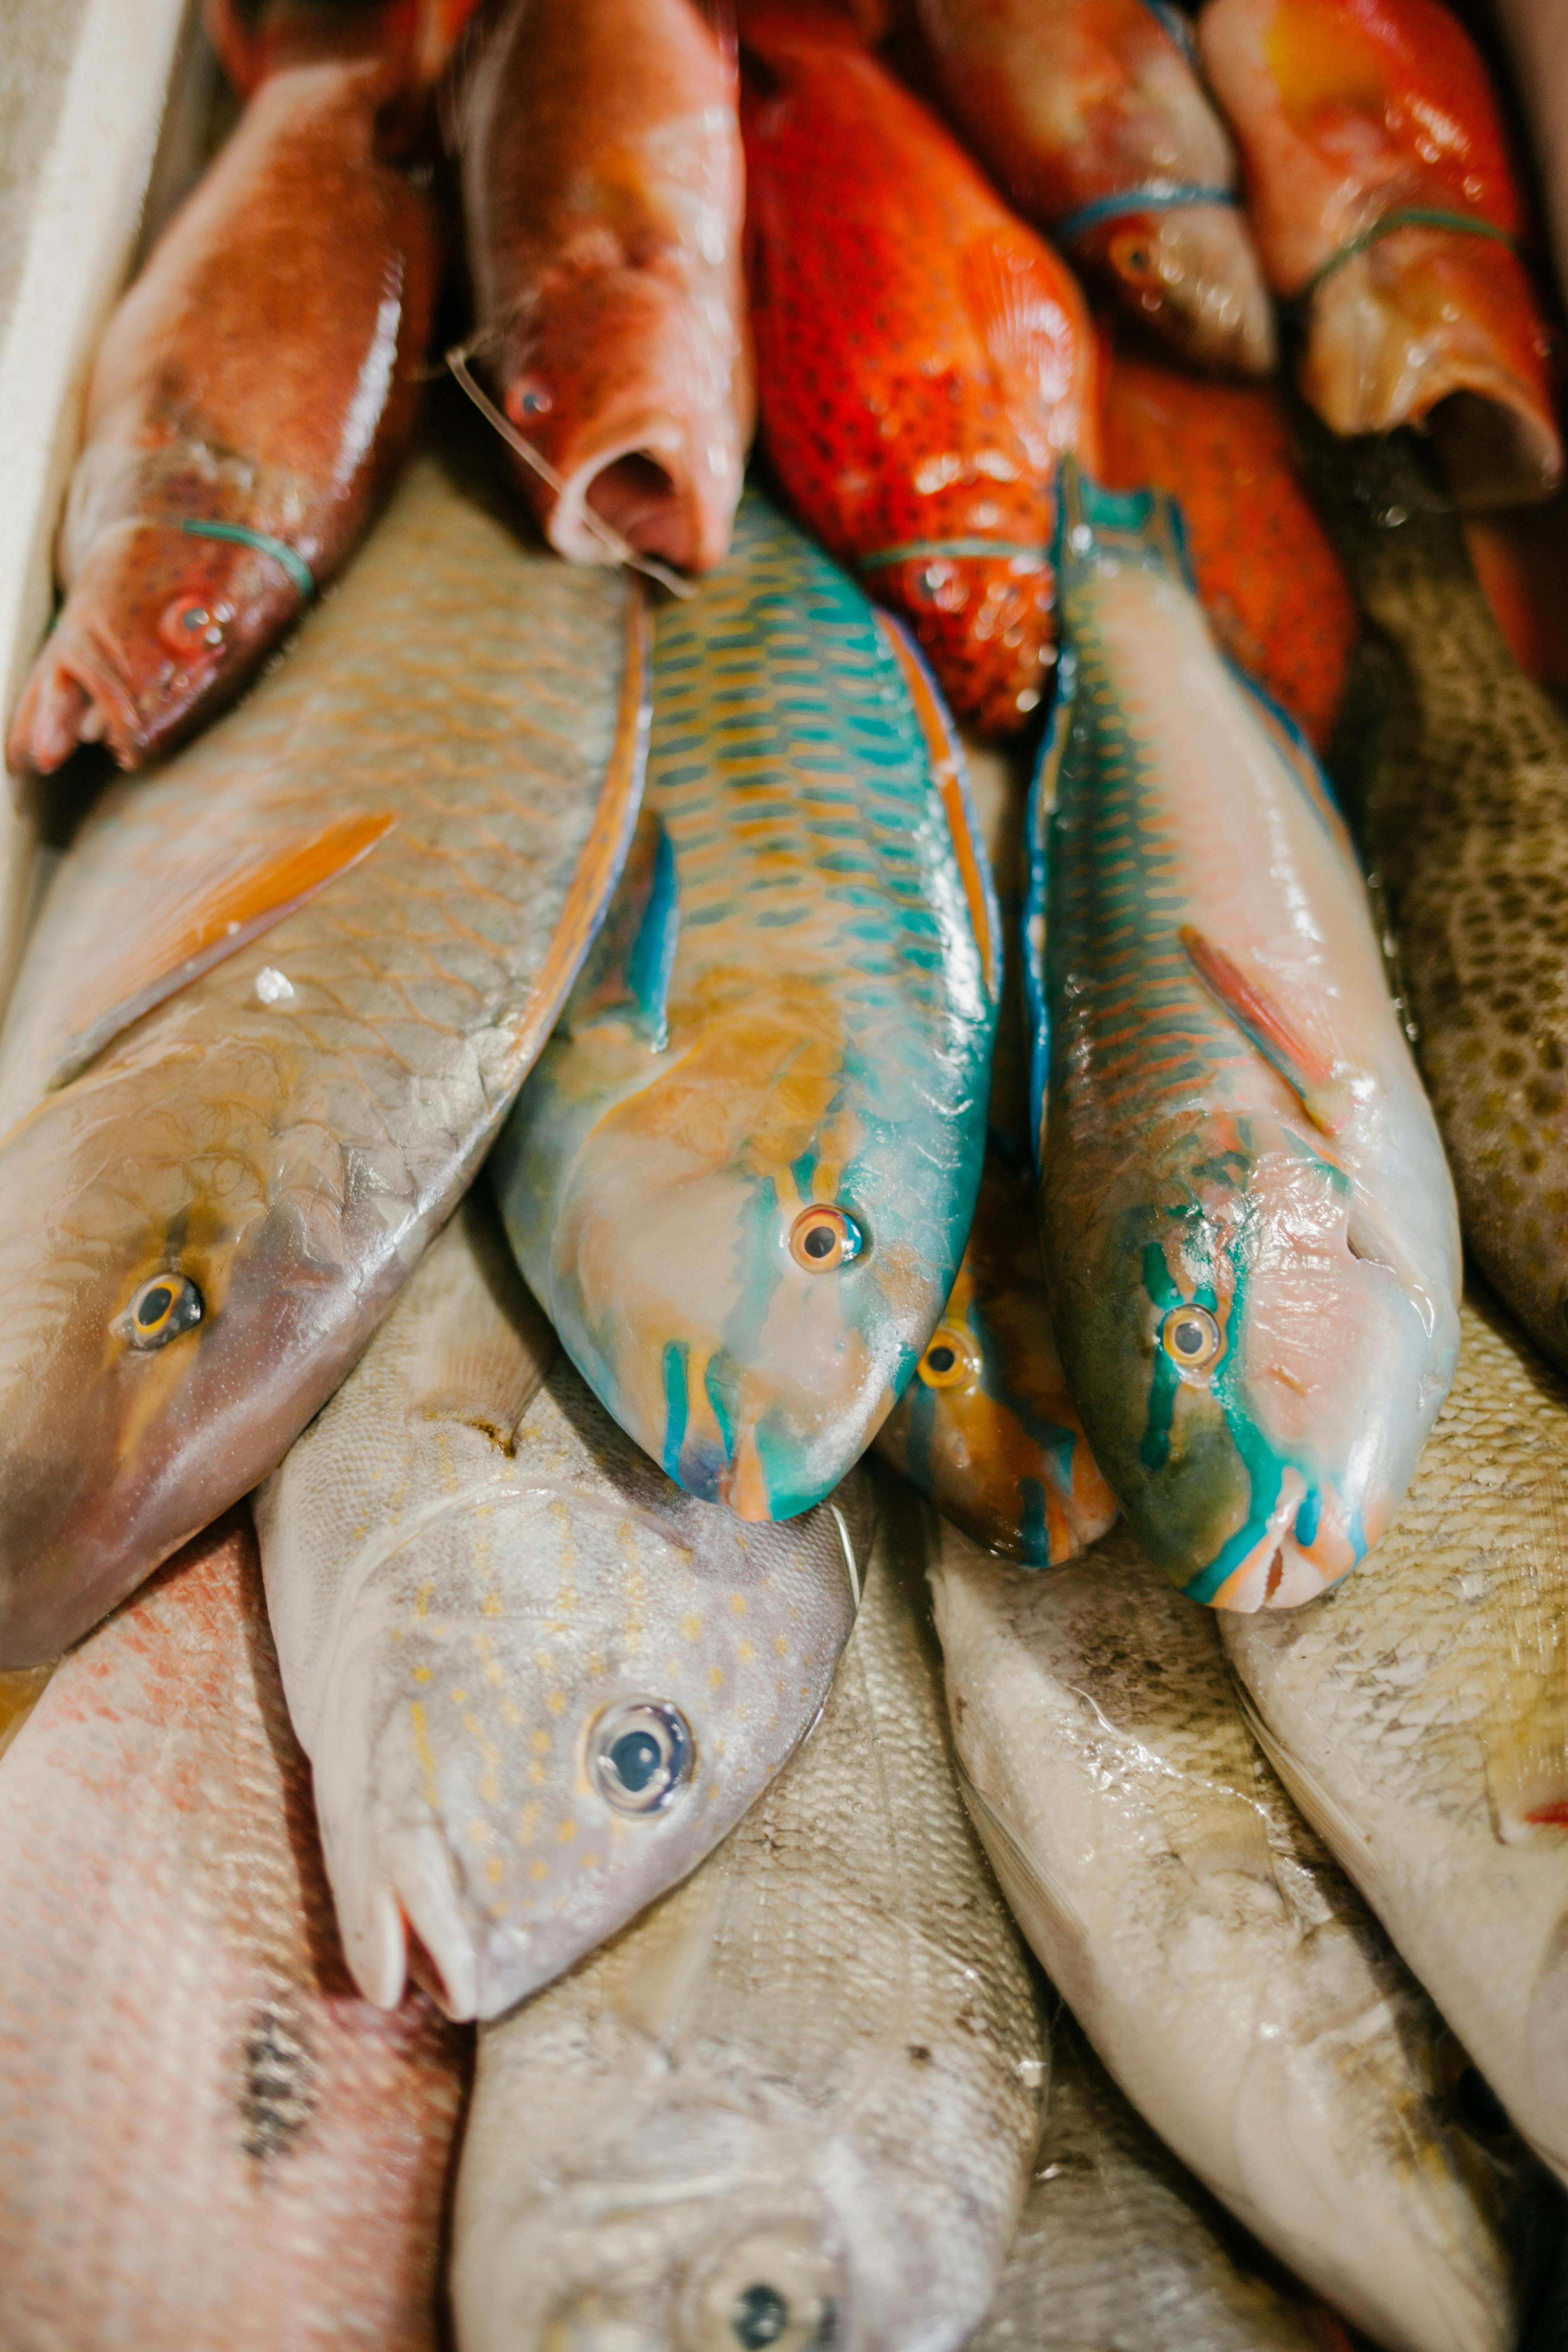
[1046,1115,1457,1609]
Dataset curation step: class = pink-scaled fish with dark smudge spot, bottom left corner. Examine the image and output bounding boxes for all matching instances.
[0,1512,468,2352]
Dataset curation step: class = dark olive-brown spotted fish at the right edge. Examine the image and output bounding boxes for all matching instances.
[1310,435,1568,1369]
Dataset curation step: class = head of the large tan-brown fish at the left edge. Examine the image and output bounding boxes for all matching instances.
[0,1042,390,1668]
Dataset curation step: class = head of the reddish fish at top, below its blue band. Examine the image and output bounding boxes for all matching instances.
[1074,202,1279,377]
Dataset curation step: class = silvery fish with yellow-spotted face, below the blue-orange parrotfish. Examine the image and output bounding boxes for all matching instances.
[256,1192,872,2018]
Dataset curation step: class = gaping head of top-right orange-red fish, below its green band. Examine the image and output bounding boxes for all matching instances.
[1302,228,1563,508]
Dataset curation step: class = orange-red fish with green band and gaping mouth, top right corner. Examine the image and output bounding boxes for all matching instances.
[1199,0,1563,508]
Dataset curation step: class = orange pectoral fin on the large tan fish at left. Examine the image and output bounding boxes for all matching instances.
[47,812,397,1091]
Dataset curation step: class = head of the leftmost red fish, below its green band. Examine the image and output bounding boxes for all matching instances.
[7,522,303,776]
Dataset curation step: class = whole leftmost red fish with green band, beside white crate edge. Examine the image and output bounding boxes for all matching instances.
[7,61,437,774]
